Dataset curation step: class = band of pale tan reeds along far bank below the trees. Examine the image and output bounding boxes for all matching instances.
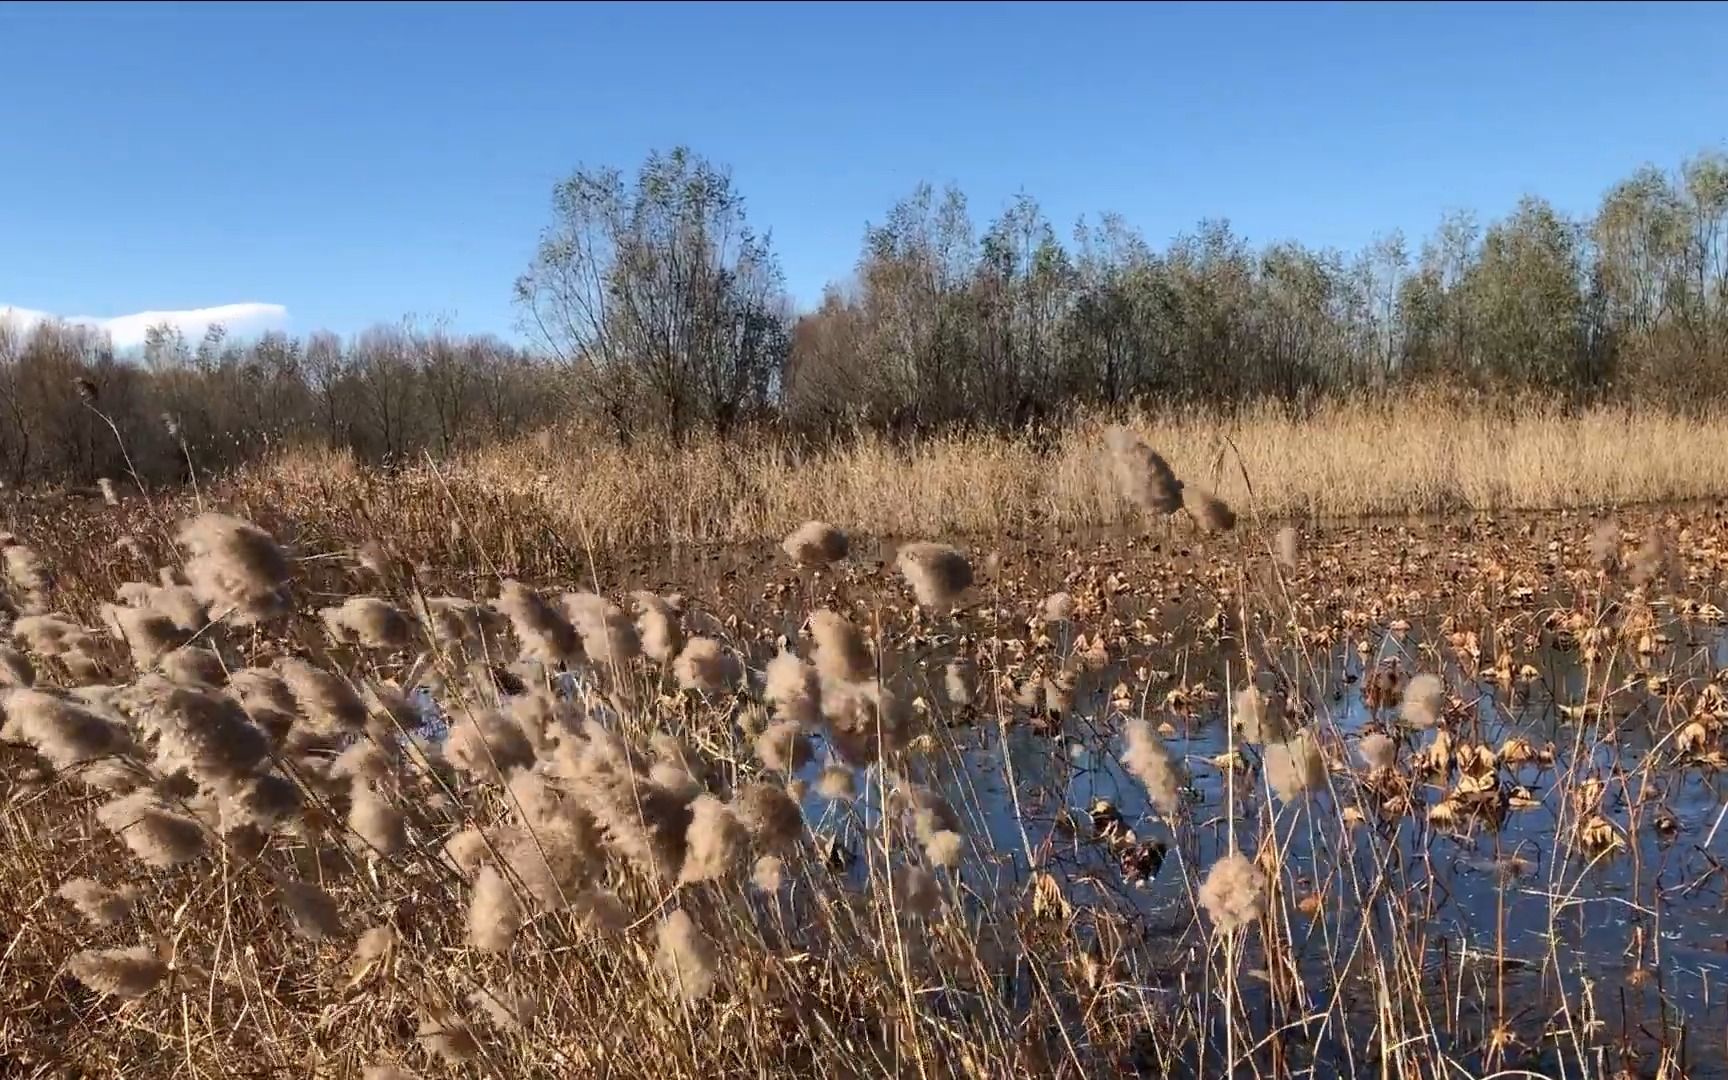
[233,397,1728,550]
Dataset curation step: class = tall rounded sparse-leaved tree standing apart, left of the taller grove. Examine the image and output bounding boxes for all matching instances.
[517,149,790,437]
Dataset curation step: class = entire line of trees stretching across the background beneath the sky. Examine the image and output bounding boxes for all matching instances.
[0,149,1728,484]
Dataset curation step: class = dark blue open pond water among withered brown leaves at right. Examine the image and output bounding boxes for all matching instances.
[860,601,1728,1077]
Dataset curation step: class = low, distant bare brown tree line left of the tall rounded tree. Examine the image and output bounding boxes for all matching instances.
[0,323,563,486]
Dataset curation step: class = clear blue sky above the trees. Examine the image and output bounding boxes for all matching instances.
[0,3,1728,337]
